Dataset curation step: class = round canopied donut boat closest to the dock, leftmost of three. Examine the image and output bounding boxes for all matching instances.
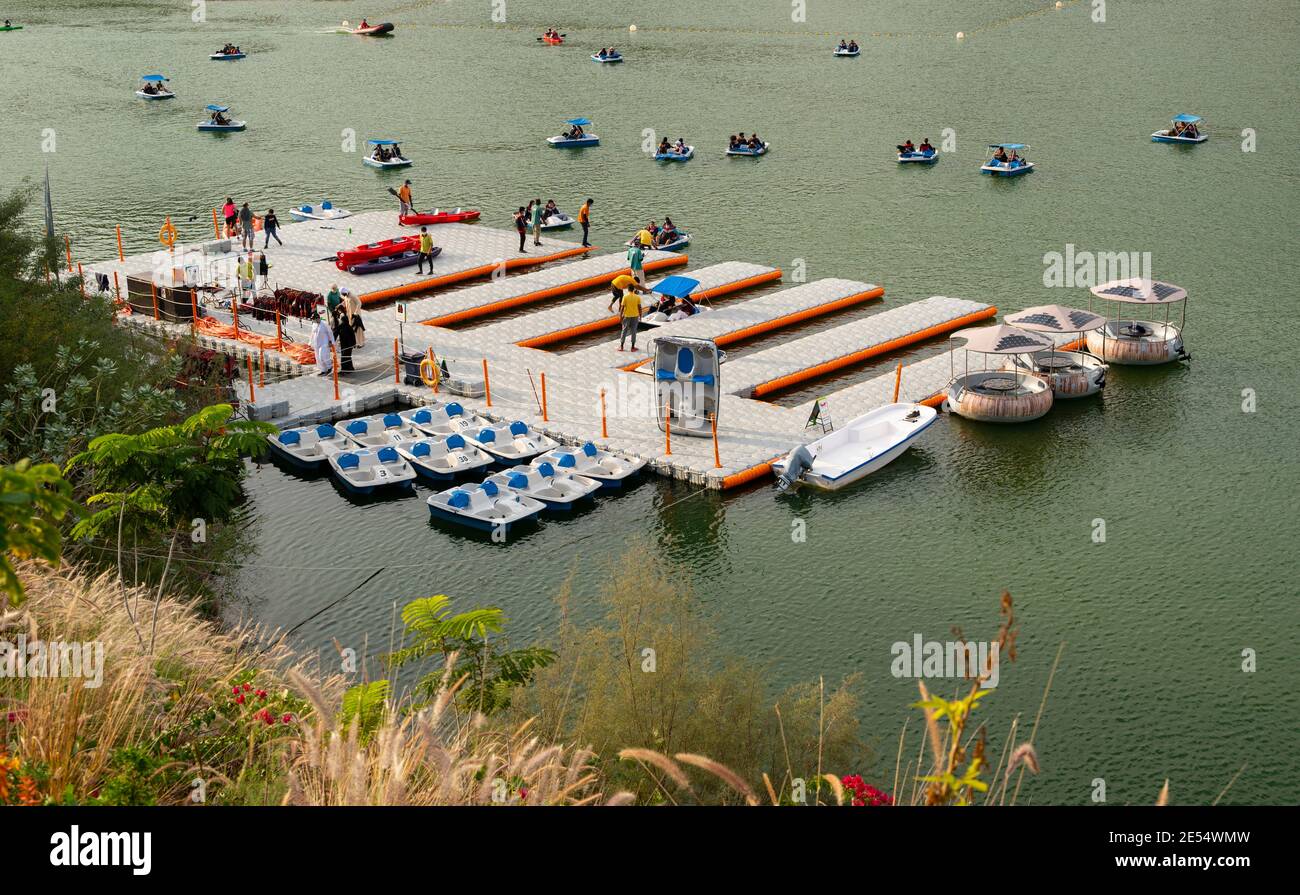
[944,324,1056,423]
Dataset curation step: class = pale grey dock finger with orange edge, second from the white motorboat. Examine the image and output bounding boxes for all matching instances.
[722,295,997,398]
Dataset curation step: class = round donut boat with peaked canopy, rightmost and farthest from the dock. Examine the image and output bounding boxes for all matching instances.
[1088,278,1192,366]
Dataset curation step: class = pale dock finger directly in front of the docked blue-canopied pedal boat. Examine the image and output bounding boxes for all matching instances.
[567,279,885,369]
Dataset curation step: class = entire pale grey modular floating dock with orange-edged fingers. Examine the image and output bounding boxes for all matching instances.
[87,212,996,489]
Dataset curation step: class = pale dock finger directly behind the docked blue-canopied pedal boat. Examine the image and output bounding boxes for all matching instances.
[475,259,781,347]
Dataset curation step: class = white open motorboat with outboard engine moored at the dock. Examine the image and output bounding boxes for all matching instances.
[772,402,939,490]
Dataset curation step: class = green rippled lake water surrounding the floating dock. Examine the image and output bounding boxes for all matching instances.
[0,0,1300,804]
